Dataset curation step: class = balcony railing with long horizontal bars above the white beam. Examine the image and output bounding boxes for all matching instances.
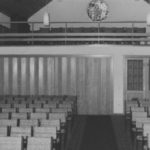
[0,21,150,45]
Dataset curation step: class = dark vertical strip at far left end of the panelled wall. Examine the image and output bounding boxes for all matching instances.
[0,57,4,95]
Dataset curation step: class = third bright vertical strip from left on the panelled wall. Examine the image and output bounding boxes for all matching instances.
[21,58,26,95]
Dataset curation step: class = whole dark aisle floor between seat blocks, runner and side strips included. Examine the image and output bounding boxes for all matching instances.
[66,115,133,150]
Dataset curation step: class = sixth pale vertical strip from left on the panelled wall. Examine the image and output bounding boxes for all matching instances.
[47,57,55,95]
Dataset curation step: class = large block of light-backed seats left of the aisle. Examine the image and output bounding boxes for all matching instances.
[0,95,77,150]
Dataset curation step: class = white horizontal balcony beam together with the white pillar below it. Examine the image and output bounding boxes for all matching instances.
[0,45,150,113]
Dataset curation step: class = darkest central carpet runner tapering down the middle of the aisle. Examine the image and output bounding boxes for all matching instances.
[80,116,118,150]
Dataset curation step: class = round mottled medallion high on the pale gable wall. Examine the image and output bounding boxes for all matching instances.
[87,0,108,21]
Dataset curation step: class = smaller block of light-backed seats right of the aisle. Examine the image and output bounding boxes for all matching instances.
[125,98,150,150]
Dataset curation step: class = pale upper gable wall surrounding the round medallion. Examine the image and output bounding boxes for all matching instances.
[29,0,150,22]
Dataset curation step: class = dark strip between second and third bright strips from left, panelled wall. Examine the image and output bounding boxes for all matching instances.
[17,57,21,95]
